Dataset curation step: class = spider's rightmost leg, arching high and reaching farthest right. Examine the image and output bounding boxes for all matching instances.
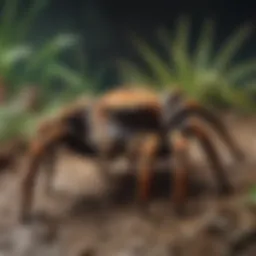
[168,100,245,160]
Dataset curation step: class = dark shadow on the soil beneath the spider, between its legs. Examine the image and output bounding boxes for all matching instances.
[67,161,212,215]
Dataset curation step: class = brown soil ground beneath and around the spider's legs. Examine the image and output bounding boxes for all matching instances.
[0,115,256,256]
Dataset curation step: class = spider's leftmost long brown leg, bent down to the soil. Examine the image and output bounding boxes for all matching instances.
[20,125,68,223]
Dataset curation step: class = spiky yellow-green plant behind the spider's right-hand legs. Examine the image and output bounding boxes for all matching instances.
[121,17,256,109]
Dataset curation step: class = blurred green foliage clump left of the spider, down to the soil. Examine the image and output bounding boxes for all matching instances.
[0,0,97,144]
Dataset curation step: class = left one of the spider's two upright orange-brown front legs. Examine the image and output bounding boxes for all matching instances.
[138,135,159,202]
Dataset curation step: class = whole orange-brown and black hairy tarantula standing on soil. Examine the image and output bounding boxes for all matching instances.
[20,85,243,222]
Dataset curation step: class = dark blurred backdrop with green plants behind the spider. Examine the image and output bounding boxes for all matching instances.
[0,0,256,143]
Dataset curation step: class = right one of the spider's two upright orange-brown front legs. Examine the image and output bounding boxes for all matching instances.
[171,132,192,213]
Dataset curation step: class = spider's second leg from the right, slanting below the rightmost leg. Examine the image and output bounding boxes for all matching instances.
[182,121,233,194]
